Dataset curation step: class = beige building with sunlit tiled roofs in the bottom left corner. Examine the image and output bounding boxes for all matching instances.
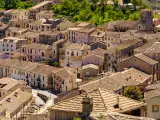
[0,78,33,120]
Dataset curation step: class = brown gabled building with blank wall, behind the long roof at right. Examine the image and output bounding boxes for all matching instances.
[117,53,159,82]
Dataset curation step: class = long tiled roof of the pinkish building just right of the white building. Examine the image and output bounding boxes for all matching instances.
[21,43,52,50]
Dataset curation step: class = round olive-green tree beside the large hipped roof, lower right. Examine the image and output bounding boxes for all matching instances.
[124,86,143,101]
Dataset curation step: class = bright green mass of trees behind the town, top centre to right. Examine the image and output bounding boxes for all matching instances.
[52,0,146,25]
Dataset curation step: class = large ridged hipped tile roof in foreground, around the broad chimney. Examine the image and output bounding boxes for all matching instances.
[49,88,146,113]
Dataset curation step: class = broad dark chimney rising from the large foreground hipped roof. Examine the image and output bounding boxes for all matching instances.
[82,94,93,117]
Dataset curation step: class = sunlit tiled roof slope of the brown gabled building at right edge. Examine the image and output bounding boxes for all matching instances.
[134,53,158,65]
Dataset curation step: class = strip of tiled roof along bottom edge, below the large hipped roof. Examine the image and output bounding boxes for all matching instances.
[87,112,154,120]
